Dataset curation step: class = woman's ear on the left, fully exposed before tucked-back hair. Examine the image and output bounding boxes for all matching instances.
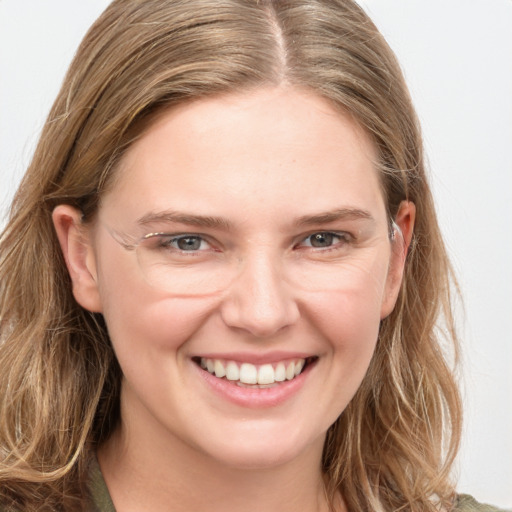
[52,204,102,313]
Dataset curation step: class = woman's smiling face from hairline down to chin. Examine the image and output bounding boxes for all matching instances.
[60,88,413,467]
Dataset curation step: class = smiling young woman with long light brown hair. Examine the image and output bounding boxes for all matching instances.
[0,0,504,512]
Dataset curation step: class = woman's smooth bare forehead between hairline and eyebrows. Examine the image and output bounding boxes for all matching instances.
[101,87,385,228]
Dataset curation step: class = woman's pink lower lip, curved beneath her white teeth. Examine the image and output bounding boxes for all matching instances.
[193,361,317,409]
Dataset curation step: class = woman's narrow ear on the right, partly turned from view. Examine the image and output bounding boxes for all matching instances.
[380,201,416,320]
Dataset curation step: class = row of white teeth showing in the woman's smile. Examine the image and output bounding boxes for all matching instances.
[193,356,318,388]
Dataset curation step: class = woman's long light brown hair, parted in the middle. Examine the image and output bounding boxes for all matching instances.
[0,0,461,512]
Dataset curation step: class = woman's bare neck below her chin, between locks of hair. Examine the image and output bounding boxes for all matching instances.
[98,416,344,512]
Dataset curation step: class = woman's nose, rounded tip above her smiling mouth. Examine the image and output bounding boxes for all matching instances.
[221,254,300,338]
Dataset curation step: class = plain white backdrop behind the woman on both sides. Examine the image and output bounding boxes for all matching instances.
[0,0,512,507]
